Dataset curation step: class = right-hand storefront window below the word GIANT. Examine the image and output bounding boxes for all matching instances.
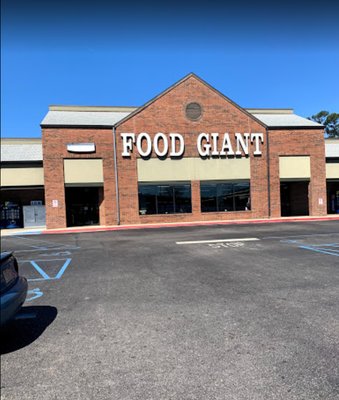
[200,182,251,212]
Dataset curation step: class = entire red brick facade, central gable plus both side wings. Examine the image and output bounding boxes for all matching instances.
[43,76,326,228]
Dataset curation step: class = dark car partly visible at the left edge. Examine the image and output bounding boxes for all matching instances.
[0,252,28,326]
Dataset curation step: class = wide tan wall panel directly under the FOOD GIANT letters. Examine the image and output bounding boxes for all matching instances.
[138,157,251,182]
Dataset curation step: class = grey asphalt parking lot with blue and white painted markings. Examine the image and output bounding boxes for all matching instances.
[1,221,339,400]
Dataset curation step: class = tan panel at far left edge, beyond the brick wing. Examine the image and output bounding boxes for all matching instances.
[1,168,44,186]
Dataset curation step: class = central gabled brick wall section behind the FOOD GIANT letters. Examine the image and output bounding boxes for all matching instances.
[117,77,268,224]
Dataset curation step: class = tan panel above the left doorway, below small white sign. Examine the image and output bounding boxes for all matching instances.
[64,159,104,183]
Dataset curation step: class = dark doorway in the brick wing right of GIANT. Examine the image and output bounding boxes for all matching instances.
[280,181,309,217]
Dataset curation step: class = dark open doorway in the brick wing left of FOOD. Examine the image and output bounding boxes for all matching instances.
[65,187,100,226]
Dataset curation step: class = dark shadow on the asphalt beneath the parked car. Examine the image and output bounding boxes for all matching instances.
[0,306,58,354]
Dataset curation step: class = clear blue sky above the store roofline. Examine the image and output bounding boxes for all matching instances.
[1,0,339,137]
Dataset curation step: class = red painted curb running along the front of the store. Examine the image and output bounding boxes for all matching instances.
[41,215,339,235]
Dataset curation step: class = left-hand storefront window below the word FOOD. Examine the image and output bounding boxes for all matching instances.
[139,183,192,215]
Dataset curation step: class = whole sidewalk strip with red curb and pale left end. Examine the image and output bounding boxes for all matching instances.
[1,214,339,237]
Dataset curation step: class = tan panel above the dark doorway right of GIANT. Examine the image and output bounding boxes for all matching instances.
[279,156,311,179]
